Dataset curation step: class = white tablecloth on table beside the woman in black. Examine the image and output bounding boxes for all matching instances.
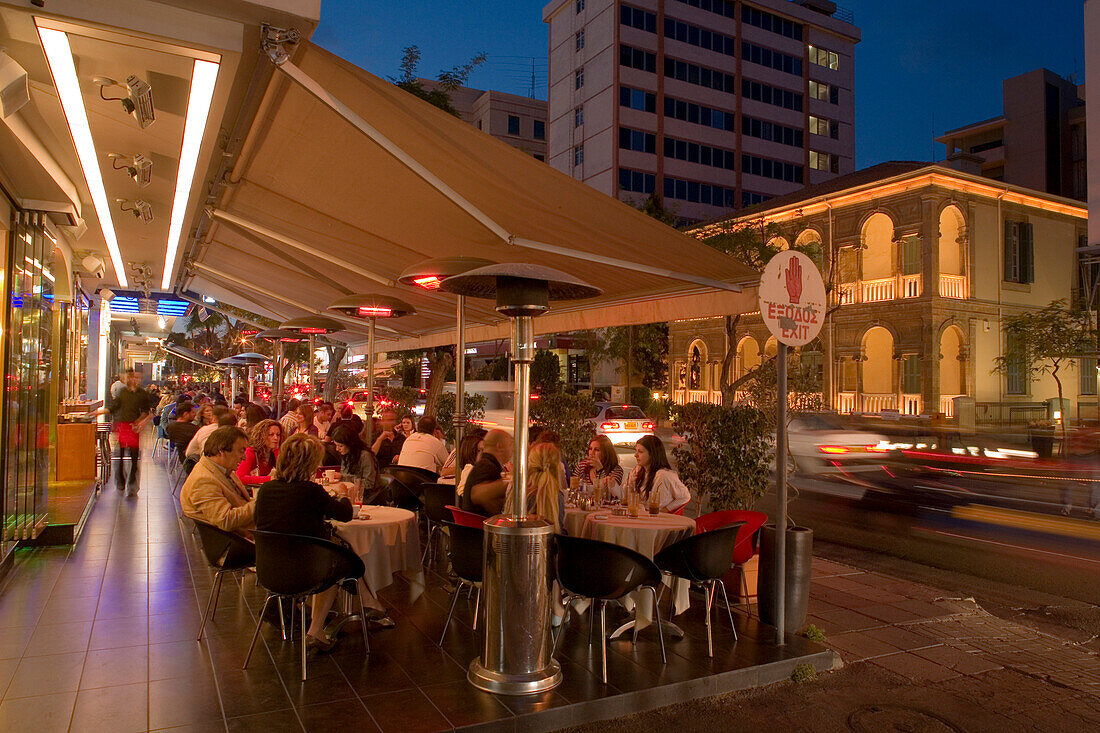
[333,505,424,593]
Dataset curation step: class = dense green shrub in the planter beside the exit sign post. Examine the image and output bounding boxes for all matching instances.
[672,403,771,513]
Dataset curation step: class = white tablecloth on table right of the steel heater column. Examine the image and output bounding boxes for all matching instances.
[567,511,695,630]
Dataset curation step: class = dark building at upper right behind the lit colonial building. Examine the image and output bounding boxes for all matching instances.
[936,68,1088,201]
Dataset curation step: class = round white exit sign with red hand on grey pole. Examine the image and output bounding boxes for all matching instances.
[759,250,826,646]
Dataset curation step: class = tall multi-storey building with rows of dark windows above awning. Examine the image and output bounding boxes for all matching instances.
[542,0,859,221]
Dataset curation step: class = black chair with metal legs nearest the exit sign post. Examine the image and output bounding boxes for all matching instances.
[653,522,745,657]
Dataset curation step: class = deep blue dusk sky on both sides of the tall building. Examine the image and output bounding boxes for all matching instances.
[314,0,1085,167]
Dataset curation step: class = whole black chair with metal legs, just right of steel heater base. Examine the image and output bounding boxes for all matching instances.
[553,535,667,685]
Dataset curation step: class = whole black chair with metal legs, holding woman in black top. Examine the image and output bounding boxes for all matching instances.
[244,529,371,680]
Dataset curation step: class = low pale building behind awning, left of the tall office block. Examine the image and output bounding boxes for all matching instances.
[417,79,547,161]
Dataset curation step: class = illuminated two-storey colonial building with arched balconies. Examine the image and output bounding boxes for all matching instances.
[669,162,1097,422]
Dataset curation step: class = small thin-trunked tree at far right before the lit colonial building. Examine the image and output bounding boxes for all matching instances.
[992,299,1097,455]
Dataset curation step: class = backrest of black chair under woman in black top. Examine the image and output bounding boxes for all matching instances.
[253,529,354,595]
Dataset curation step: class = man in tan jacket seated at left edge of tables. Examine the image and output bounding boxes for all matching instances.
[179,426,256,537]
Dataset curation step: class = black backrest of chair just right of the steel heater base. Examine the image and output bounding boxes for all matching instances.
[553,535,661,600]
